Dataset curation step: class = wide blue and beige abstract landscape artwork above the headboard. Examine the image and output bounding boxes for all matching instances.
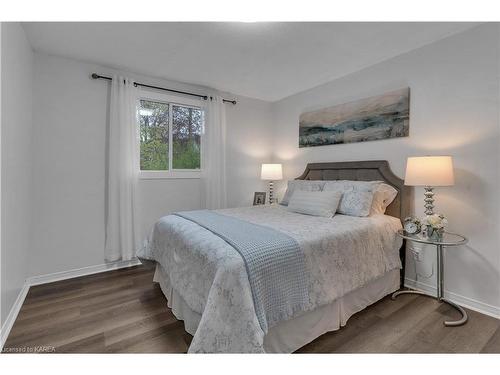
[299,88,410,147]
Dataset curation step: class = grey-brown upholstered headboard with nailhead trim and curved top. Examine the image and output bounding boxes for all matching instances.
[296,160,413,220]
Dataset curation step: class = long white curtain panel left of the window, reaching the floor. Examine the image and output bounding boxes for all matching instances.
[105,76,140,261]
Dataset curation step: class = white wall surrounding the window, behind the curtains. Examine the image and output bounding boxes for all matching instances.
[30,53,271,275]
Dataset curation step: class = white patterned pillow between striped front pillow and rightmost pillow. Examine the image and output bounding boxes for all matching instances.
[323,180,381,217]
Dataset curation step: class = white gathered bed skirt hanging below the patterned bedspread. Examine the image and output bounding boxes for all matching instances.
[153,264,400,353]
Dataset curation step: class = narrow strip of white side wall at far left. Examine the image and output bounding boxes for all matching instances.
[0,22,33,325]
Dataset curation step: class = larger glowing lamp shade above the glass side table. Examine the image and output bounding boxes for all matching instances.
[405,156,455,186]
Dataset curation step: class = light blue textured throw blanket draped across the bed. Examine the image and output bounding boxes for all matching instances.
[174,210,309,333]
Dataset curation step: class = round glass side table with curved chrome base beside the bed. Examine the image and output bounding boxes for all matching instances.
[392,229,467,326]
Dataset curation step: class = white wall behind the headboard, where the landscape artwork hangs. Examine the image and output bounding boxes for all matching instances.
[273,24,500,314]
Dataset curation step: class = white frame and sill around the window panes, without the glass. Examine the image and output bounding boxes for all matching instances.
[135,90,205,180]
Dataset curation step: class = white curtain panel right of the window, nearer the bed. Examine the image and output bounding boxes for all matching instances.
[201,96,227,209]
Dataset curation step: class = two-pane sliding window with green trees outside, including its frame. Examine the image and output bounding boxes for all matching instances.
[137,93,204,178]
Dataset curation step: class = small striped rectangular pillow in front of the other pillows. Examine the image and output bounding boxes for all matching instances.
[288,190,342,217]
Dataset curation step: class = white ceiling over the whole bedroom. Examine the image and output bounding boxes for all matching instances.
[23,22,476,101]
